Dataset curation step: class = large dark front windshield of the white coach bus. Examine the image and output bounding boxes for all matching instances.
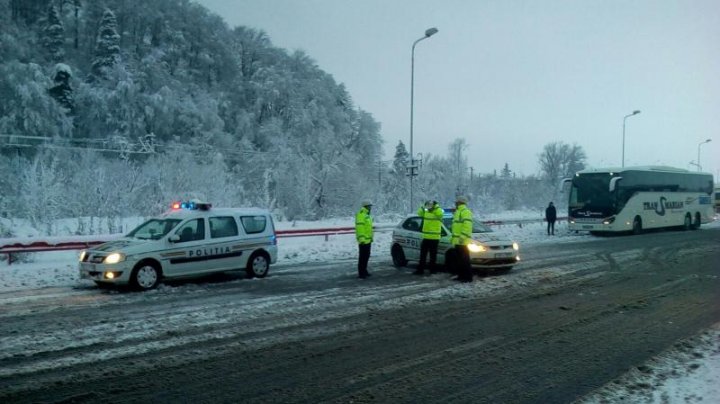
[569,173,614,217]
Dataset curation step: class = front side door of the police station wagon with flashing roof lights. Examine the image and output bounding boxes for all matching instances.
[162,218,209,277]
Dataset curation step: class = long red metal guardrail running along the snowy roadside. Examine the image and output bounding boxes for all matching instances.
[0,217,556,265]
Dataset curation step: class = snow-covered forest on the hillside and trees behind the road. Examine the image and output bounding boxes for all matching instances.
[0,0,584,235]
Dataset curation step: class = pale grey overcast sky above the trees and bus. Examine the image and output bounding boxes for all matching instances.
[197,0,720,176]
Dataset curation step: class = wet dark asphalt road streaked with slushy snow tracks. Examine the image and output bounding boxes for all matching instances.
[0,228,720,402]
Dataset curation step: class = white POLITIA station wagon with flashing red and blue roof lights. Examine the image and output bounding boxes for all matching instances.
[79,201,277,290]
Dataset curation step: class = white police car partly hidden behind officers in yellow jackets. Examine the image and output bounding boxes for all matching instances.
[390,210,520,270]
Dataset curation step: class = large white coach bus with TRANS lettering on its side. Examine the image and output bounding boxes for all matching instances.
[563,167,713,234]
